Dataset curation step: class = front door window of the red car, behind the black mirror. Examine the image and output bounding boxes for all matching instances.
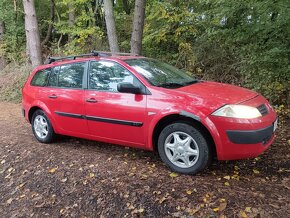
[89,61,140,92]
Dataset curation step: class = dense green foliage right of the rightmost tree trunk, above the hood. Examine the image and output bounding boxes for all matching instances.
[144,0,290,104]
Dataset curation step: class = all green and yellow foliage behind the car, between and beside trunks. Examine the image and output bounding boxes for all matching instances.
[0,0,290,108]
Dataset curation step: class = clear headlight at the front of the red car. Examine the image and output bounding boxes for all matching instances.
[212,104,262,119]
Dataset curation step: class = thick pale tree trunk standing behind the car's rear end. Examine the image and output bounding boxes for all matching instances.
[23,0,42,67]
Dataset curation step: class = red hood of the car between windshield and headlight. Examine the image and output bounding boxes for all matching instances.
[175,81,258,112]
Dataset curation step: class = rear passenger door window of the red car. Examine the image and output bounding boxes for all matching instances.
[58,62,85,88]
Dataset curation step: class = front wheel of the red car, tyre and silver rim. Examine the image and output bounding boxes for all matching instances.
[158,122,212,174]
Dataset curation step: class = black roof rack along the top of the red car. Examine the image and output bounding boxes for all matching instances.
[47,50,136,64]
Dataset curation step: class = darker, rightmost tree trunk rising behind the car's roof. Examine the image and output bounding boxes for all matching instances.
[131,0,146,55]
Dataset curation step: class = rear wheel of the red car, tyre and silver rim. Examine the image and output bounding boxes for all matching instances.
[31,110,55,144]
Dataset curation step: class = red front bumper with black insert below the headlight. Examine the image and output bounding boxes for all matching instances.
[205,96,277,160]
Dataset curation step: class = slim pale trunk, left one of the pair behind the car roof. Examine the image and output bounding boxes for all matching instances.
[104,0,119,52]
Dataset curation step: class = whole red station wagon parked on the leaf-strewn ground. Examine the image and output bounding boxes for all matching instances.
[22,52,277,174]
